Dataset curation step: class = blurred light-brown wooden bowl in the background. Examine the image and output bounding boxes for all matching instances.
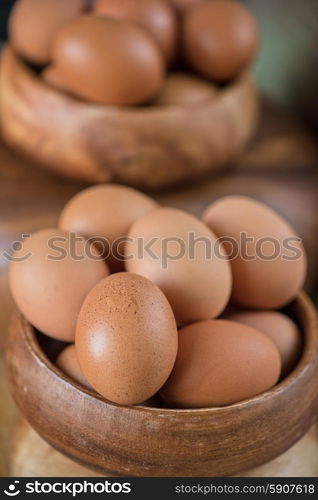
[0,47,259,189]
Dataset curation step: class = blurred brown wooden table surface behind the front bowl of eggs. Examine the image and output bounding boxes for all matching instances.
[0,96,318,476]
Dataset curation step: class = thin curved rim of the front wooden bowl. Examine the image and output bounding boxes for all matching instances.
[20,292,318,418]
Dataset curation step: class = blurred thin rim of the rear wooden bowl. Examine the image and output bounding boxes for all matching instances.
[1,42,255,118]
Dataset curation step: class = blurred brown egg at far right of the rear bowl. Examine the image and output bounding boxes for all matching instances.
[182,0,259,82]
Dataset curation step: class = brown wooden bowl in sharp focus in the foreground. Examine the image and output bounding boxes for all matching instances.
[7,294,318,477]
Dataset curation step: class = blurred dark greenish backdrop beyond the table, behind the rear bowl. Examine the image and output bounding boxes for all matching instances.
[0,0,318,126]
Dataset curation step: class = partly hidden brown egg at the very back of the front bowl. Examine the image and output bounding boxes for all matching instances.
[59,184,158,271]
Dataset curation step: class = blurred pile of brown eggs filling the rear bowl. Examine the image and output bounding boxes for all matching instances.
[9,0,259,105]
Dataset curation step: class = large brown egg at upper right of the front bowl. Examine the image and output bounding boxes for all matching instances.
[203,196,307,309]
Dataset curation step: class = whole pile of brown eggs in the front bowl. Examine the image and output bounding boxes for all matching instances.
[9,184,306,408]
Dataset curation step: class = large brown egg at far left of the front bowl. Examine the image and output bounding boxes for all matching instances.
[9,229,109,342]
